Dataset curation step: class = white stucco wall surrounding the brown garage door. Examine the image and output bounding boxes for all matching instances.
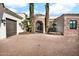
[0,13,22,39]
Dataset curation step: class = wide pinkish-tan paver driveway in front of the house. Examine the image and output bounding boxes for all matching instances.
[0,34,79,56]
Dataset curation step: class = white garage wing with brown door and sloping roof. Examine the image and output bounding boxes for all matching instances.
[0,3,24,39]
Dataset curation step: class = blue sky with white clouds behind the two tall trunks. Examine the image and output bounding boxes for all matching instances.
[4,0,79,16]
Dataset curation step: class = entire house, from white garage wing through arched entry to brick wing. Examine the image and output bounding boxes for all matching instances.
[0,3,79,39]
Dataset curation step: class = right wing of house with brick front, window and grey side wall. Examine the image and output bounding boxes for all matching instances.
[54,13,79,36]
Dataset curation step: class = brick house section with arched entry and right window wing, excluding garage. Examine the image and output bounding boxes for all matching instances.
[34,13,79,36]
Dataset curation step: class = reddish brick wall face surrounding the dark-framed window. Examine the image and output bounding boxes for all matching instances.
[64,14,79,35]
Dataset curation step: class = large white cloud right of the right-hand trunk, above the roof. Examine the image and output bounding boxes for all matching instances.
[49,3,77,15]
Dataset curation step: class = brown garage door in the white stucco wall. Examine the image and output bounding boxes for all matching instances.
[6,18,17,37]
